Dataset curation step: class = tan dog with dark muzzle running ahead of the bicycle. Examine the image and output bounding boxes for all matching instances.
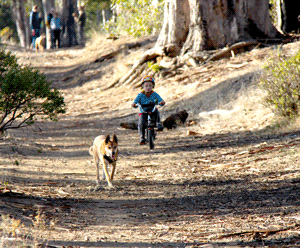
[89,134,118,188]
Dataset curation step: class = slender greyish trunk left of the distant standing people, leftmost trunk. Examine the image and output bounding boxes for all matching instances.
[12,0,30,48]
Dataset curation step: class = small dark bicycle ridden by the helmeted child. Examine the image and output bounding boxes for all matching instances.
[138,103,161,150]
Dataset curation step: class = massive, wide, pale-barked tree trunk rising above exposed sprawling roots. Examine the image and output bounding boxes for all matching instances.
[156,0,279,56]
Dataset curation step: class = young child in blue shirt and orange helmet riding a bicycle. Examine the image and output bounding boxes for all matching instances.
[131,75,165,145]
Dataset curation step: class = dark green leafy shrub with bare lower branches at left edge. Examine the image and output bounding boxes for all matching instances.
[0,50,65,134]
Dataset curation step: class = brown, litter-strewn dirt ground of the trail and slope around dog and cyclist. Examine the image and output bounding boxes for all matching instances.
[0,39,300,247]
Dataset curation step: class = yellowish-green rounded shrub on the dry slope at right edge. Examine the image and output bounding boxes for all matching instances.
[261,52,300,119]
